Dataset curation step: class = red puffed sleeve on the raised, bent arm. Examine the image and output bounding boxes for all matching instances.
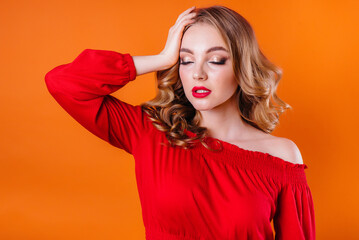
[45,49,145,154]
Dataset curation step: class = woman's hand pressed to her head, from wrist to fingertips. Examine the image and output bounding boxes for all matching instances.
[159,7,196,68]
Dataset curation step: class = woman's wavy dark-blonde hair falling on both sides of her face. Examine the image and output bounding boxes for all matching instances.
[141,5,292,150]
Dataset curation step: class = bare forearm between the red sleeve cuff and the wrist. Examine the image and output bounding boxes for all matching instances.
[132,54,173,76]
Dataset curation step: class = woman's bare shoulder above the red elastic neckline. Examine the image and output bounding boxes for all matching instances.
[262,135,303,164]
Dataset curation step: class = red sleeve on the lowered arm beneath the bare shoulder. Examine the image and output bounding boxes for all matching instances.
[273,164,315,240]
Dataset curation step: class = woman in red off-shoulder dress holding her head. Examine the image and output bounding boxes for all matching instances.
[45,6,315,240]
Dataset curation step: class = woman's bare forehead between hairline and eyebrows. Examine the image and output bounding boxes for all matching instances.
[181,23,226,51]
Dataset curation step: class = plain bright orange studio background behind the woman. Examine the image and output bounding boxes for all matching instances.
[0,0,359,240]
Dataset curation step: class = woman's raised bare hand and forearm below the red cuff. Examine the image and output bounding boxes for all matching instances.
[132,7,196,76]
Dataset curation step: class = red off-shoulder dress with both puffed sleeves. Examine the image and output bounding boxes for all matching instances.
[45,49,315,240]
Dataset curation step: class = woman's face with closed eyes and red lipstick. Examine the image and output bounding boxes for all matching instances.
[179,23,238,111]
